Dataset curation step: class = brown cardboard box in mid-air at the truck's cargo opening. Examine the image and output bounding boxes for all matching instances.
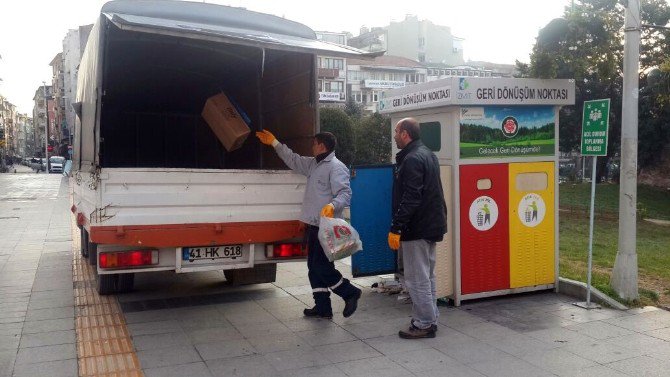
[202,93,251,152]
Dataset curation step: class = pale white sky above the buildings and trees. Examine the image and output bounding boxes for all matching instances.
[0,0,570,115]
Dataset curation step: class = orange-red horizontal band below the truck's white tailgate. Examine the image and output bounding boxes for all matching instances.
[90,220,304,247]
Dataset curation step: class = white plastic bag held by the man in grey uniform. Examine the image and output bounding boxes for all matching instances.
[319,216,363,262]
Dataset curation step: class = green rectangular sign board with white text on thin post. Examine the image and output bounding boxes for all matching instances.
[582,98,610,156]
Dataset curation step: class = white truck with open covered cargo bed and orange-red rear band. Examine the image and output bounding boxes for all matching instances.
[72,0,378,294]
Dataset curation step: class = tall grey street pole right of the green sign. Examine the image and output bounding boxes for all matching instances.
[611,0,640,300]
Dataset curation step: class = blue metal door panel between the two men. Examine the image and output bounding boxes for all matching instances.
[351,165,397,277]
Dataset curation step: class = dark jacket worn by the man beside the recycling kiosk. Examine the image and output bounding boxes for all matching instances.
[391,140,447,242]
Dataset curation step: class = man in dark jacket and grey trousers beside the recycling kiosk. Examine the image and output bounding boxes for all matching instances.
[388,118,447,339]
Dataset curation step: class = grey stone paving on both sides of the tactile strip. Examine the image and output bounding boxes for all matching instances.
[0,174,670,377]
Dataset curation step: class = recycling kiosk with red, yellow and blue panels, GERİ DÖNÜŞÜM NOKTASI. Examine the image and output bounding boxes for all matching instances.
[352,77,575,305]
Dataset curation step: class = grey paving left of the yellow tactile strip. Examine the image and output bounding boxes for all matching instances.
[0,172,77,376]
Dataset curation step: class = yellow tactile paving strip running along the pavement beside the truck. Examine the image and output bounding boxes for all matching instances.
[72,212,144,377]
